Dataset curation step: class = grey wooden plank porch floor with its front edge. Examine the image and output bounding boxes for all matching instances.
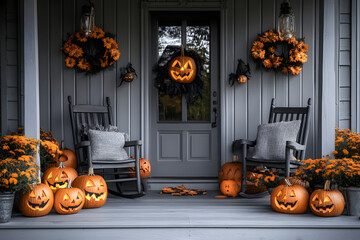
[0,191,360,240]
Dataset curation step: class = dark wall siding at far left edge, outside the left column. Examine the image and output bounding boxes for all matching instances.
[1,0,20,134]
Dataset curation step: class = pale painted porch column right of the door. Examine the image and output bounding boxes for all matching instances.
[319,0,337,156]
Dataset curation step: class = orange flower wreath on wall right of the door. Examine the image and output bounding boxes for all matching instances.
[251,29,309,75]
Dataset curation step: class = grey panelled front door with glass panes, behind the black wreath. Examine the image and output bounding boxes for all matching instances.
[150,13,220,178]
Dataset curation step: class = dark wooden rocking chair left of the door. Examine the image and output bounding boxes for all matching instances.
[68,96,145,198]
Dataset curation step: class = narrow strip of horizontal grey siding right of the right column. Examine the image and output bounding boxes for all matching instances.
[336,0,351,129]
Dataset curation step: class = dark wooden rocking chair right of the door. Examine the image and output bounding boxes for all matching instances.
[233,98,311,197]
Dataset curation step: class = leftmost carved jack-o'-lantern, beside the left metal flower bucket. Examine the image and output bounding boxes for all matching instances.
[19,183,54,217]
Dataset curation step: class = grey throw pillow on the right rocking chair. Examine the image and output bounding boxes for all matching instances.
[252,120,301,160]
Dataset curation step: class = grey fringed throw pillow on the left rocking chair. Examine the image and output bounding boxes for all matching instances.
[89,129,129,161]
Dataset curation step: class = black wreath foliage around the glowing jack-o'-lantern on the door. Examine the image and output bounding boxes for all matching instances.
[153,45,204,104]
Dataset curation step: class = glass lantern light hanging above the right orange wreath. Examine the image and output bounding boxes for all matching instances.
[277,0,295,38]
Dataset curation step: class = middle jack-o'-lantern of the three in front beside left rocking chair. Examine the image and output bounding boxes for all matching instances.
[54,179,85,214]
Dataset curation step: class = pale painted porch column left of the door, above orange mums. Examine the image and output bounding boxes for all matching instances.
[24,0,40,176]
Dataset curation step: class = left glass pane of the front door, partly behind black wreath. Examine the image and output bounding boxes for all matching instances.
[158,26,182,121]
